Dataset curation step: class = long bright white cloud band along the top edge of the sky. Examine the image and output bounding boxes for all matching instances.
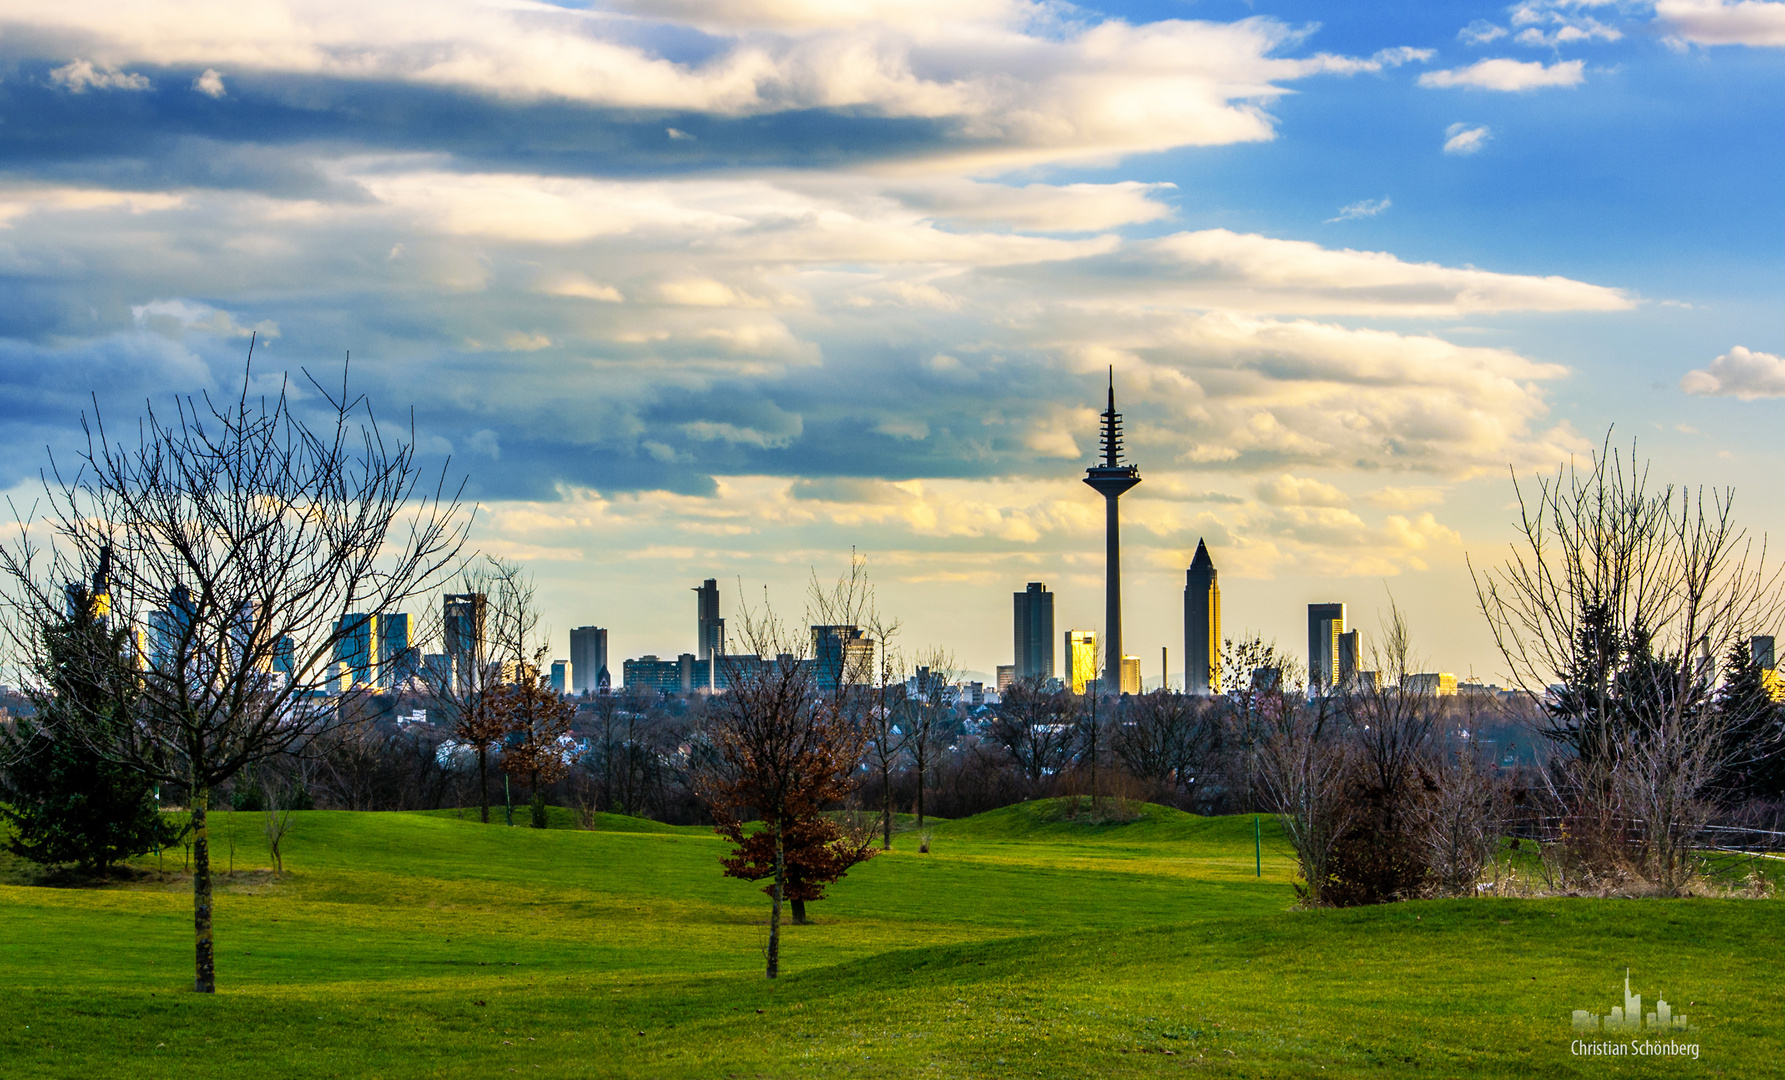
[0,0,1428,168]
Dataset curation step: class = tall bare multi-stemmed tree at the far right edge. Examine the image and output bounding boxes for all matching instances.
[1471,441,1780,893]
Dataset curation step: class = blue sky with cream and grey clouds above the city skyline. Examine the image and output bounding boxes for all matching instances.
[0,0,1785,684]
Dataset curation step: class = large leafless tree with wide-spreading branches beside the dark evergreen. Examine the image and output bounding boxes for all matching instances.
[0,352,468,993]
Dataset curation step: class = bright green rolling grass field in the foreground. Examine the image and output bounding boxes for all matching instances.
[0,803,1785,1080]
